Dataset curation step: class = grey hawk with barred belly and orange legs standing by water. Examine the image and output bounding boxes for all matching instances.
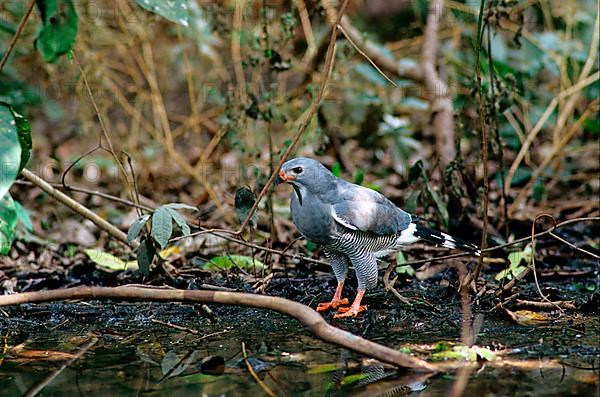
[275,157,481,318]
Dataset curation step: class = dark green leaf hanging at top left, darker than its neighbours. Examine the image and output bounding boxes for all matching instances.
[35,0,77,62]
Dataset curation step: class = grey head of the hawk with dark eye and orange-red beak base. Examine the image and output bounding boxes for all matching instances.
[276,157,335,202]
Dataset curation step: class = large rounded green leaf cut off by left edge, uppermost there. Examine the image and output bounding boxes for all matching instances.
[0,104,22,197]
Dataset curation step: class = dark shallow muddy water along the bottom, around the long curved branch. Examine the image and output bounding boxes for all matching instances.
[0,302,600,396]
